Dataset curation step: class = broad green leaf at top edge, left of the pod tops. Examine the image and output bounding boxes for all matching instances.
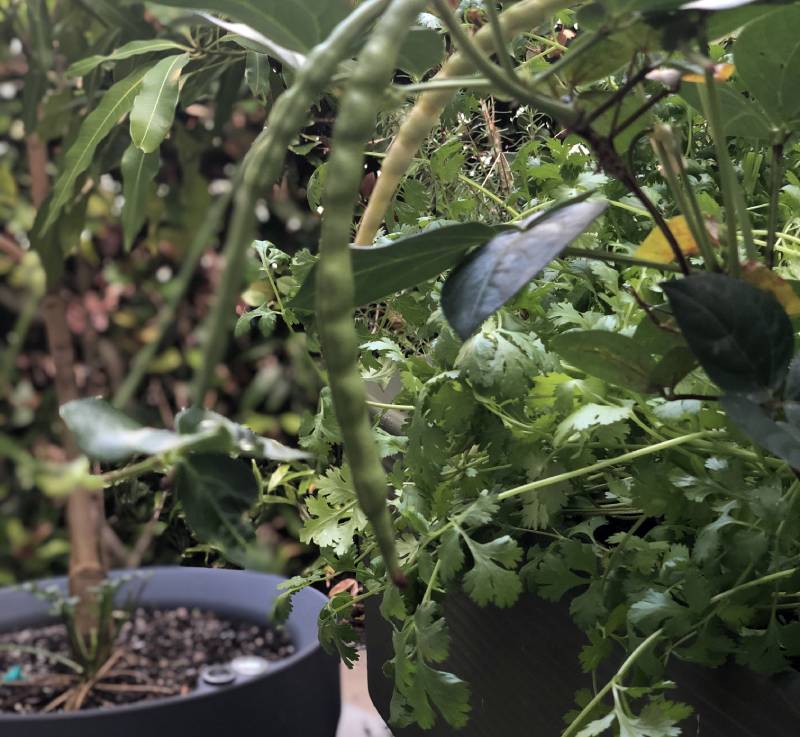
[152,0,352,52]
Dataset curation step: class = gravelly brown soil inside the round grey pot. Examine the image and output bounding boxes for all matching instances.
[0,608,294,713]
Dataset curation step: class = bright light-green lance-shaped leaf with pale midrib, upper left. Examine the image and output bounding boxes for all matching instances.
[131,54,190,154]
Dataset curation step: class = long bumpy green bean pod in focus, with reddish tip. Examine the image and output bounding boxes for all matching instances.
[315,0,426,585]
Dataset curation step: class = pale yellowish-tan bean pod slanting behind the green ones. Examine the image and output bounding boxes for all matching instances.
[355,0,569,245]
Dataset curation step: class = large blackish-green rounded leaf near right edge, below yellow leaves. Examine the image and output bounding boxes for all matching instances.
[662,274,794,392]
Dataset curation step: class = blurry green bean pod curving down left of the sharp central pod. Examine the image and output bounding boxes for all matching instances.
[192,0,390,406]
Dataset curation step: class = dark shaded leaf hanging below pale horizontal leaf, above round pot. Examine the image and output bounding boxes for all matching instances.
[175,453,259,550]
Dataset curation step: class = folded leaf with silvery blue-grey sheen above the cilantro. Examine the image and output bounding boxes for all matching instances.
[442,200,606,340]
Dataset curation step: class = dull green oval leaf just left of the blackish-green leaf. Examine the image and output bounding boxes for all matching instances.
[551,330,655,392]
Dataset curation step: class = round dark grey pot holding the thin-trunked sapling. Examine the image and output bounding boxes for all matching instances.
[0,568,340,737]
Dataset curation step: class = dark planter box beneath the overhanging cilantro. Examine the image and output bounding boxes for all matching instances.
[367,594,800,737]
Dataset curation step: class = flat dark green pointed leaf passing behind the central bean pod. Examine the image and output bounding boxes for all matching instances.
[290,223,497,312]
